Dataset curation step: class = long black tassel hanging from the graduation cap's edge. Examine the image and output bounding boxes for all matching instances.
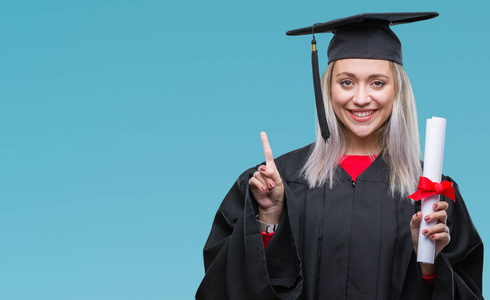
[311,34,330,142]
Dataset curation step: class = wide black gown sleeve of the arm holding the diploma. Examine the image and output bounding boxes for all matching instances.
[404,177,483,300]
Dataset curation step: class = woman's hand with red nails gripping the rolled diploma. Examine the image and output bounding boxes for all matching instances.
[410,201,451,275]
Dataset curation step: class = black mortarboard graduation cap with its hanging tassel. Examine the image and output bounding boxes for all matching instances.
[286,12,439,141]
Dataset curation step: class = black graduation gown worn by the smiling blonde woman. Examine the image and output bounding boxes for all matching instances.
[196,145,483,300]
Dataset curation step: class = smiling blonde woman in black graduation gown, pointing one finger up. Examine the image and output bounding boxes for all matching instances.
[196,14,483,299]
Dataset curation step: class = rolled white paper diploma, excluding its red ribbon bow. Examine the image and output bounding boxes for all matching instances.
[417,117,446,264]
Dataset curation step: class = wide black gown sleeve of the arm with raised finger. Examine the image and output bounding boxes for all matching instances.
[196,169,302,300]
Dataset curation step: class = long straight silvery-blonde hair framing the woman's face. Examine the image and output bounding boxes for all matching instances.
[301,62,422,196]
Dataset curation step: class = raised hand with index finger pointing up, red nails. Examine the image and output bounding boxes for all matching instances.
[248,132,284,224]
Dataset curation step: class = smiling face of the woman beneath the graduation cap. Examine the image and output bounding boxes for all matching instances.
[331,59,395,140]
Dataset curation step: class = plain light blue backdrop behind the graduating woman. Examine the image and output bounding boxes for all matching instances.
[0,0,490,300]
